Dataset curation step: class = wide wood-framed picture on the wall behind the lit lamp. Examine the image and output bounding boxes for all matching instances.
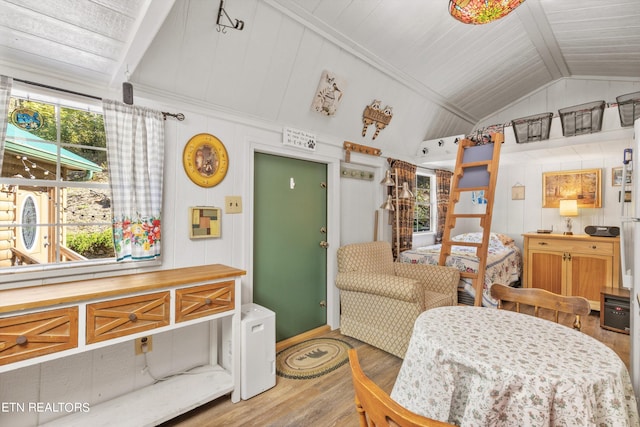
[542,169,602,208]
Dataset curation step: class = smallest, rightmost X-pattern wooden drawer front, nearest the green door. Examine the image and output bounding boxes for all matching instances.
[176,281,235,323]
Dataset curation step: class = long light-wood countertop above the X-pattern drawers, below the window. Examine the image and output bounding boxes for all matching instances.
[0,264,247,314]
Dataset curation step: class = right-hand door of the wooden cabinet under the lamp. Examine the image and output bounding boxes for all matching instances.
[567,253,613,304]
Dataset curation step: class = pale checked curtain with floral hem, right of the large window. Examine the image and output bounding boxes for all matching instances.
[103,100,164,261]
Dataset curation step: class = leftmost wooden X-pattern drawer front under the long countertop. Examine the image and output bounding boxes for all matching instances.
[0,307,78,365]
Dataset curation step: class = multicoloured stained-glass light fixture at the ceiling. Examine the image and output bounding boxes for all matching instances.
[449,0,524,25]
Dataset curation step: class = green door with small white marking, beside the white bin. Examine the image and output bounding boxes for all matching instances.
[253,153,327,341]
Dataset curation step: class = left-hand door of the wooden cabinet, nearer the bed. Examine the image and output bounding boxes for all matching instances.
[527,250,565,294]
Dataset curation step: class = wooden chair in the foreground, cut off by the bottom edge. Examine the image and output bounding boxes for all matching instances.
[349,349,453,427]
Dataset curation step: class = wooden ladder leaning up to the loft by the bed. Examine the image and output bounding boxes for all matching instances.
[439,133,504,306]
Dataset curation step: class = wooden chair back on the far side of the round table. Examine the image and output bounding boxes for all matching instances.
[491,283,591,330]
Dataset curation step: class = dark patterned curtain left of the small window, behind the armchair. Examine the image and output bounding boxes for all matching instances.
[387,159,416,258]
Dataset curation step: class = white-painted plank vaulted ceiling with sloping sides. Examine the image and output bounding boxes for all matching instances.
[0,0,640,160]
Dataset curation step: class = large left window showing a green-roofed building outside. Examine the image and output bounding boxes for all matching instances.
[0,87,115,274]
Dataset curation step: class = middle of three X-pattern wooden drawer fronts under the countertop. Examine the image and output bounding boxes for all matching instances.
[87,291,170,344]
